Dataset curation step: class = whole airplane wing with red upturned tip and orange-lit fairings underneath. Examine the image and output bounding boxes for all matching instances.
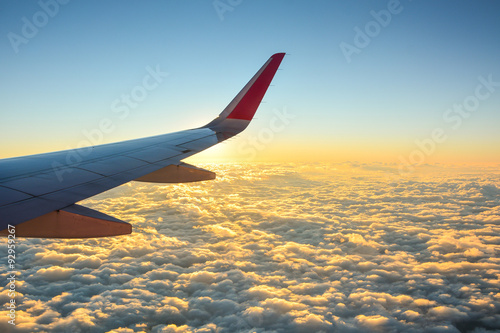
[0,53,285,238]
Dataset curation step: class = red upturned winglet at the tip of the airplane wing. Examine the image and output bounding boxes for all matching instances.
[227,53,285,120]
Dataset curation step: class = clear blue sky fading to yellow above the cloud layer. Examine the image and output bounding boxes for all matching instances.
[0,0,500,163]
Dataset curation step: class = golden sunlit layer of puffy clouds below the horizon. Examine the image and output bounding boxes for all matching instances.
[0,164,500,333]
